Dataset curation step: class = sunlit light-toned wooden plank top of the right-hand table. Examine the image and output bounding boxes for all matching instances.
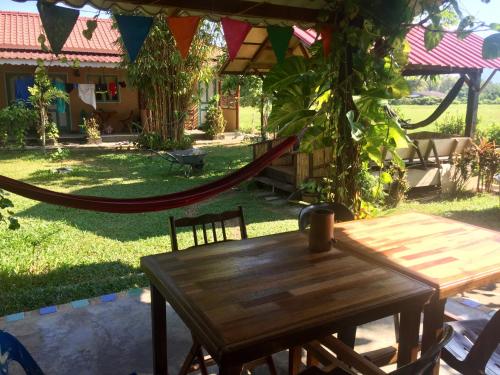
[335,213,500,298]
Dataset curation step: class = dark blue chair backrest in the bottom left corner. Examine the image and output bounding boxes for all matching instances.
[0,330,43,375]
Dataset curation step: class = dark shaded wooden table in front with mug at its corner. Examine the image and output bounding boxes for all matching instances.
[141,232,433,374]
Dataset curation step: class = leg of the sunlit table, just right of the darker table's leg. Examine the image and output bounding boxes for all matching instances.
[422,297,446,375]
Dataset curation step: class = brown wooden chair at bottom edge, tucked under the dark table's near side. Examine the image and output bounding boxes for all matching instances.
[301,325,453,375]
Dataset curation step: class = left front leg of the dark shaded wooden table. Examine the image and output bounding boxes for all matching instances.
[151,284,168,375]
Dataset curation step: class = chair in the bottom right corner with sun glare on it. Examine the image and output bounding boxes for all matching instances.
[442,311,500,374]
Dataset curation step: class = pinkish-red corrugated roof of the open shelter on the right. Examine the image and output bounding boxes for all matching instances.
[406,27,500,69]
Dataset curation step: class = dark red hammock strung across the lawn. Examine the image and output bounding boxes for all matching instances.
[0,136,297,214]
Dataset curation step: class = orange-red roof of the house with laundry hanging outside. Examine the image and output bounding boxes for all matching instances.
[0,11,121,64]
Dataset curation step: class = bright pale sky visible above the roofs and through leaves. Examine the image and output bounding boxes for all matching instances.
[0,0,500,82]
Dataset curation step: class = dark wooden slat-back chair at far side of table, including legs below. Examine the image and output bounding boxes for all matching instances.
[170,206,277,375]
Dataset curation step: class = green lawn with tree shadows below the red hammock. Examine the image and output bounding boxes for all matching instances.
[0,145,500,316]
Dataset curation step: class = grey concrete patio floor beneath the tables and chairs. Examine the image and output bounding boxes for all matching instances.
[0,284,500,375]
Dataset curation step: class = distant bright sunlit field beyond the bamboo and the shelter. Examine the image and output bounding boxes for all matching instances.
[240,104,500,133]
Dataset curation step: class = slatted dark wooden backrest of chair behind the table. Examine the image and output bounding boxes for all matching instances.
[170,206,248,251]
